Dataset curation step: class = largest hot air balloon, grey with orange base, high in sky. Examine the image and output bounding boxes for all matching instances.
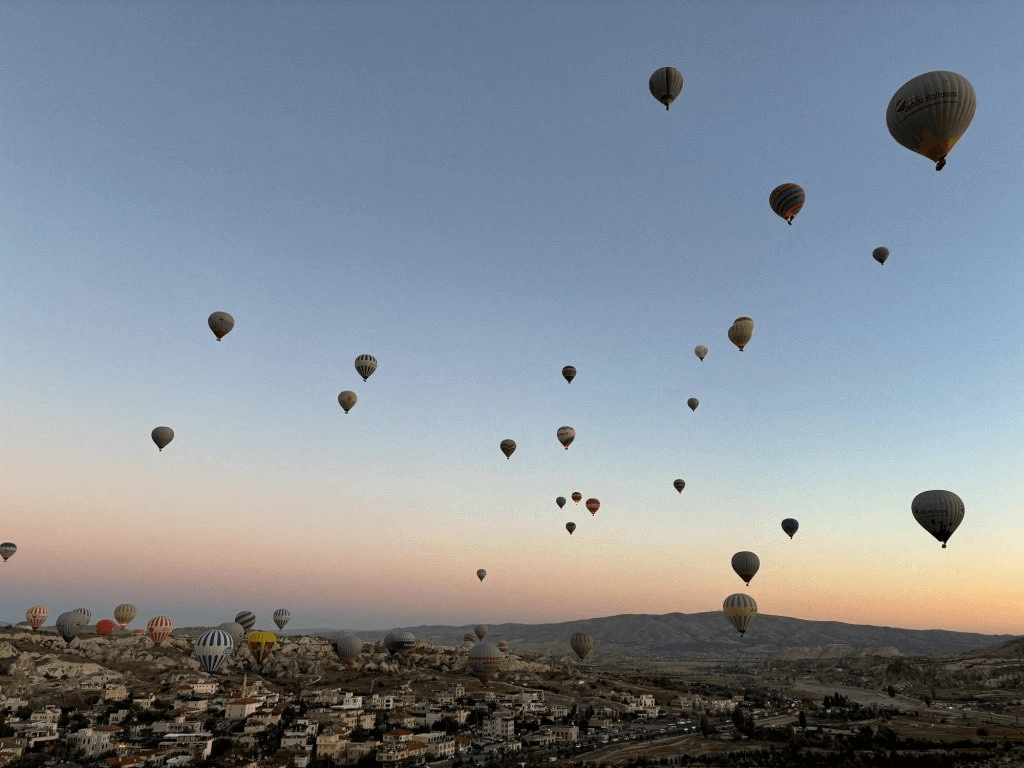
[886,72,977,171]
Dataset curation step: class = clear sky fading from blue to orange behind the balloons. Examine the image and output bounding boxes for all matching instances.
[0,0,1024,636]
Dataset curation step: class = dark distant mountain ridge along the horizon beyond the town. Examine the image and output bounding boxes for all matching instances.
[294,611,1017,657]
